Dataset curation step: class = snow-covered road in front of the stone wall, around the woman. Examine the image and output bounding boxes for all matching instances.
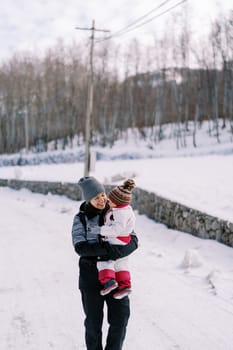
[0,188,233,350]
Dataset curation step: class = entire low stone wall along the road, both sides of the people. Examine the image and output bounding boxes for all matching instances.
[0,179,233,247]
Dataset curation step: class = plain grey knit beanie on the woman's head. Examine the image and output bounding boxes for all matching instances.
[78,176,105,203]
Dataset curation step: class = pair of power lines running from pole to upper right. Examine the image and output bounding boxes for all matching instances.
[96,0,187,43]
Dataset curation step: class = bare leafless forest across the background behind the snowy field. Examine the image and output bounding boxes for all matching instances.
[0,11,233,153]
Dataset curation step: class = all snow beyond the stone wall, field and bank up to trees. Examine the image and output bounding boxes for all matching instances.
[0,122,233,222]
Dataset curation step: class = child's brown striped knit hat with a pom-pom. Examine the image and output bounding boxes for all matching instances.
[108,179,136,206]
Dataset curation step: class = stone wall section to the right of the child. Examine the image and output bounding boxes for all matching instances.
[132,188,233,247]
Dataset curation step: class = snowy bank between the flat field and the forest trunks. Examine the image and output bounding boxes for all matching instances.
[0,120,233,166]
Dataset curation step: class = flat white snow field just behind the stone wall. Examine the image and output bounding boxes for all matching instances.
[0,155,233,222]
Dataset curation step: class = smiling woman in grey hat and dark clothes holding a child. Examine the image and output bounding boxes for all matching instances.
[72,177,138,350]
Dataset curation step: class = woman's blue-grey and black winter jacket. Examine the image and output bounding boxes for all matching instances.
[72,202,138,290]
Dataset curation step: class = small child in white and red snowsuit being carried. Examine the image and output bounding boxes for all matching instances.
[97,179,135,299]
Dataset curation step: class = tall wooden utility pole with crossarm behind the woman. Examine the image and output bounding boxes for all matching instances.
[75,20,109,176]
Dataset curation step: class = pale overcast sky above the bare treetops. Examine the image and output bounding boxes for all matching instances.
[0,0,233,59]
